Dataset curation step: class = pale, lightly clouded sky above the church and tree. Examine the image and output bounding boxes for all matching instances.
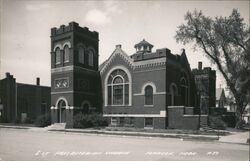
[0,0,250,87]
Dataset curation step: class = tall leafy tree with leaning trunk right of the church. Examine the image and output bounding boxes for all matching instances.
[175,9,250,128]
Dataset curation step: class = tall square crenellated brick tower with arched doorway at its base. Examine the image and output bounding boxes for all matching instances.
[50,22,101,127]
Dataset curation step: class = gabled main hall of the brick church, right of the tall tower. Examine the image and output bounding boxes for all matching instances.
[99,40,198,129]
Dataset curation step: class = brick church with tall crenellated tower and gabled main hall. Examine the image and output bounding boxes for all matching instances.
[51,22,215,129]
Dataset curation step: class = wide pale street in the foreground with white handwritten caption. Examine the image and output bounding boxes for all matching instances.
[0,128,249,161]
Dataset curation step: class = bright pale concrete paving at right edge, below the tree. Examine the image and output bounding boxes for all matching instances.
[219,131,250,144]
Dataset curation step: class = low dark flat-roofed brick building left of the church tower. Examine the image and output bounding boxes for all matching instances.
[0,73,50,122]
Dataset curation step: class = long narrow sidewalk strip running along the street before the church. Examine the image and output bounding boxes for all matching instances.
[0,125,249,145]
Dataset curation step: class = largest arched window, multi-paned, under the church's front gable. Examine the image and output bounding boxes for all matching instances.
[107,69,129,105]
